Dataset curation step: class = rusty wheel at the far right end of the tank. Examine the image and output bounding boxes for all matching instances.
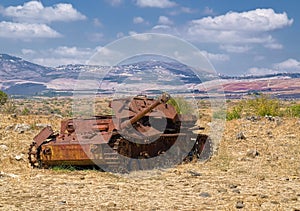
[196,135,214,161]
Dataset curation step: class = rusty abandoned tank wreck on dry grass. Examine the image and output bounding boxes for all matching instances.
[28,93,212,171]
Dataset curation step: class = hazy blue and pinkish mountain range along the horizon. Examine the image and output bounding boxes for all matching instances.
[0,54,300,96]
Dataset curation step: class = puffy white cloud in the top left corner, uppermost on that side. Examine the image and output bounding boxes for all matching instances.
[1,1,86,23]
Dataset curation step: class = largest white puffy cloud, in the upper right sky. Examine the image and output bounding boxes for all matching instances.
[187,9,293,44]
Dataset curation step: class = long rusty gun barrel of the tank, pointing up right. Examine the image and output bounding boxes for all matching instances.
[121,92,171,130]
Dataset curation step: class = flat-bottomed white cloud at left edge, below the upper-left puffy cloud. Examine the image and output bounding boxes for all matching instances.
[0,21,61,39]
